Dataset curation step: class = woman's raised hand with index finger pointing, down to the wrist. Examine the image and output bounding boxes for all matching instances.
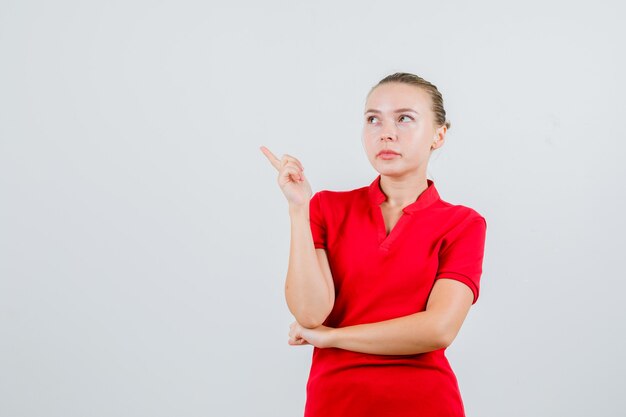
[261,146,312,206]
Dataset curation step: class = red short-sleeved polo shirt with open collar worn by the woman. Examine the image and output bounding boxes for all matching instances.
[304,175,487,417]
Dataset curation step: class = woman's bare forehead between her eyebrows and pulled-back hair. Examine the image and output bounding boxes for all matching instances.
[365,82,431,114]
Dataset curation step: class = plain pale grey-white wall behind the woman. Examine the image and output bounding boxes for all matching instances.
[0,0,626,417]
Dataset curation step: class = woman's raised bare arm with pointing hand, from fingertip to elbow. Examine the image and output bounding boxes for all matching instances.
[261,146,335,328]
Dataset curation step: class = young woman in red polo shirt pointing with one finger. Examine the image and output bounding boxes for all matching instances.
[261,73,486,417]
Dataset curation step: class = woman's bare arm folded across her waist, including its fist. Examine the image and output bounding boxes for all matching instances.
[288,278,474,355]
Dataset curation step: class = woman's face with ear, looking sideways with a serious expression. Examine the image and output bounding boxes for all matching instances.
[363,82,446,177]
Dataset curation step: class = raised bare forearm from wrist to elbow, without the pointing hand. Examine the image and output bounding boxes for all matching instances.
[285,205,335,328]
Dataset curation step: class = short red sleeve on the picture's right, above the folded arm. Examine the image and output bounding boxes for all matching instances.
[435,216,487,304]
